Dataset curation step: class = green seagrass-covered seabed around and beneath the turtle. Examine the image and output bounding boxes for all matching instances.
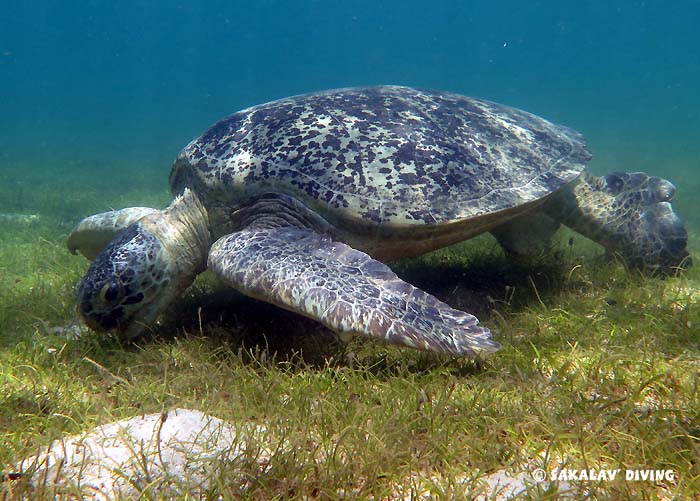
[0,170,700,499]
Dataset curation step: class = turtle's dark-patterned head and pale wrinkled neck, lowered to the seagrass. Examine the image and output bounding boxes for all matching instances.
[78,190,211,339]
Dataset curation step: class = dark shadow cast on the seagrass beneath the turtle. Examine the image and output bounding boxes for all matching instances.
[151,248,580,373]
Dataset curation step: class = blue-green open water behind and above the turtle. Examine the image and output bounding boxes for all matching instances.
[0,0,700,234]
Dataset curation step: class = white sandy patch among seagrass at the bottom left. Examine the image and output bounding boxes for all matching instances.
[18,409,269,500]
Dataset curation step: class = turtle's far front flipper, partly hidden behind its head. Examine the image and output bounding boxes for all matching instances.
[66,207,160,261]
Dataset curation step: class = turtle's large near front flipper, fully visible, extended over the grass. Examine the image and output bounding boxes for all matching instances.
[208,228,499,356]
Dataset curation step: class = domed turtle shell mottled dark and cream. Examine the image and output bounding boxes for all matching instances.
[170,86,590,227]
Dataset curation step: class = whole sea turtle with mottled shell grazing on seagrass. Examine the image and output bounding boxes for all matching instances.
[68,86,688,356]
